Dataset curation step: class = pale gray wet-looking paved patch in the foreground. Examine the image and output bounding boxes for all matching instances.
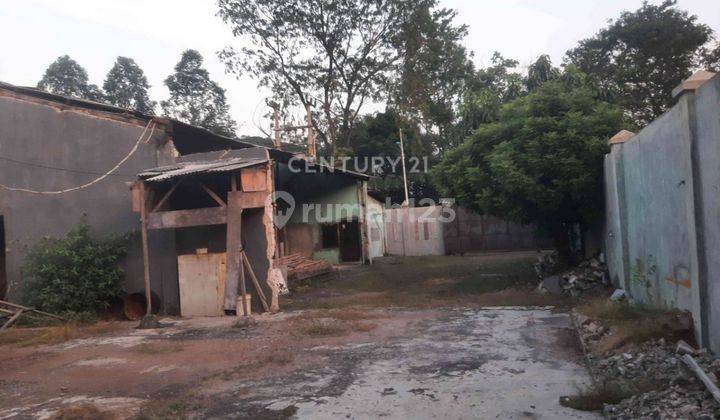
[197,308,599,419]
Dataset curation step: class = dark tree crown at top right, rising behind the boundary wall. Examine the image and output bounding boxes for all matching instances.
[568,0,712,125]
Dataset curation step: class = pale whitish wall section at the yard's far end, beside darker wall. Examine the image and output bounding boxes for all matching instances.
[385,206,445,256]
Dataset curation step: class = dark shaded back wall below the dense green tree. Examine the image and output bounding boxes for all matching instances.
[444,206,552,254]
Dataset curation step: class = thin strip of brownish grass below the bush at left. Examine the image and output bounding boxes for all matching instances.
[0,322,128,347]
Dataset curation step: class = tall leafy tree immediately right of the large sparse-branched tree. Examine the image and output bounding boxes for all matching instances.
[390,1,474,150]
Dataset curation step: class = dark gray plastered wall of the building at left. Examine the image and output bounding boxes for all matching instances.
[0,91,178,312]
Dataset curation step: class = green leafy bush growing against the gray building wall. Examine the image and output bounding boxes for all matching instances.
[24,220,128,319]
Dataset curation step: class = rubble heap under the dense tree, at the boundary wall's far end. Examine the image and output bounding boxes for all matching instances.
[535,253,609,296]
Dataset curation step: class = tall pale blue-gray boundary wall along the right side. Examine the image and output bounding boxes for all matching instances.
[605,76,720,351]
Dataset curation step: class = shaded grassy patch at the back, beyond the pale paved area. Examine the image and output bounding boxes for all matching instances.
[285,253,559,310]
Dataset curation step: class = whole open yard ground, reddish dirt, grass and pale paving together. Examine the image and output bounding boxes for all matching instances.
[0,253,593,419]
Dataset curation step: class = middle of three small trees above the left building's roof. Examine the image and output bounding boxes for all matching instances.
[103,57,155,115]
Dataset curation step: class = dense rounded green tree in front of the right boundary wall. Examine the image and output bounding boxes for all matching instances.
[432,66,623,251]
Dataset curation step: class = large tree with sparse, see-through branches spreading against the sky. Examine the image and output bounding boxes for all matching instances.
[218,0,420,155]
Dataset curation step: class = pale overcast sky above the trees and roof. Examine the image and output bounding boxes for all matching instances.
[0,0,720,135]
